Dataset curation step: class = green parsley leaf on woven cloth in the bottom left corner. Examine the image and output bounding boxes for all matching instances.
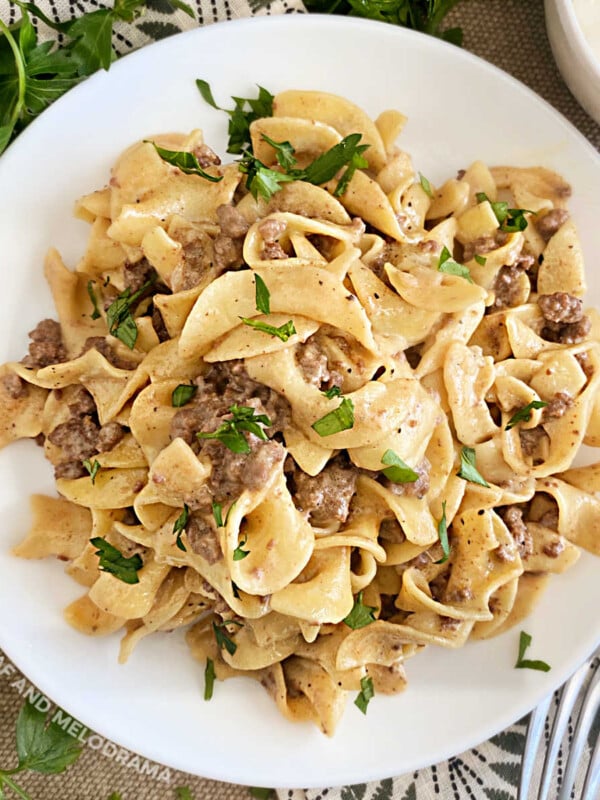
[0,700,83,800]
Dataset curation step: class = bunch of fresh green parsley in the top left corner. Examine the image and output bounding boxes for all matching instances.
[0,0,194,153]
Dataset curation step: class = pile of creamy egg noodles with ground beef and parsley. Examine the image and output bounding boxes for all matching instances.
[0,89,600,735]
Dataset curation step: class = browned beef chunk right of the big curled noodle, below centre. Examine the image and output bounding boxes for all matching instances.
[290,456,358,525]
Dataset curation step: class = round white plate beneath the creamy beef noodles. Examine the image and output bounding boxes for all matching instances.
[0,16,600,786]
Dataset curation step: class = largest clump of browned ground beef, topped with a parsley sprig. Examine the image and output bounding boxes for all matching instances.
[170,361,290,509]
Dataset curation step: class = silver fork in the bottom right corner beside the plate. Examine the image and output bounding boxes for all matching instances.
[517,650,600,800]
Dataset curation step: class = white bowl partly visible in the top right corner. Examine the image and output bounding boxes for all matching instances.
[544,0,600,124]
